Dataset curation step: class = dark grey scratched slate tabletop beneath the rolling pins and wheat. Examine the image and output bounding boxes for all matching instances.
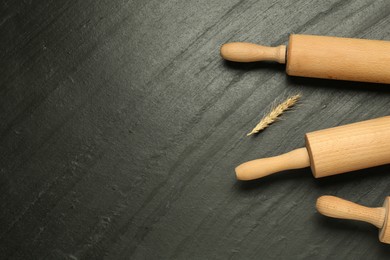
[0,0,390,259]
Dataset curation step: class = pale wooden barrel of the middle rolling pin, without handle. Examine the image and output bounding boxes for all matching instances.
[306,116,390,178]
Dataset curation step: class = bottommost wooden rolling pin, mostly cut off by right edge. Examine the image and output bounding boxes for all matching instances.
[316,196,390,244]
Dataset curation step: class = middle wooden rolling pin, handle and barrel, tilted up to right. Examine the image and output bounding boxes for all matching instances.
[235,116,390,180]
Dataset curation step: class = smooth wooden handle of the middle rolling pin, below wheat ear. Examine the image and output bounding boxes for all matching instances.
[236,148,310,181]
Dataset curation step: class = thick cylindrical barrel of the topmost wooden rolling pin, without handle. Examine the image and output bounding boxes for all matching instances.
[286,34,390,83]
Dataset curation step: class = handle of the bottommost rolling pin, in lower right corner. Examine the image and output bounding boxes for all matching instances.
[316,196,386,228]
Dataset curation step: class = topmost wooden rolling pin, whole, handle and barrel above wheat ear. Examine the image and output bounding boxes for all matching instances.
[221,34,390,84]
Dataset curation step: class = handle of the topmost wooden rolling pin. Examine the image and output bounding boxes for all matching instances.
[221,42,286,64]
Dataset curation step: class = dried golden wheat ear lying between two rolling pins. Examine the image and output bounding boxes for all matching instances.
[247,94,301,136]
